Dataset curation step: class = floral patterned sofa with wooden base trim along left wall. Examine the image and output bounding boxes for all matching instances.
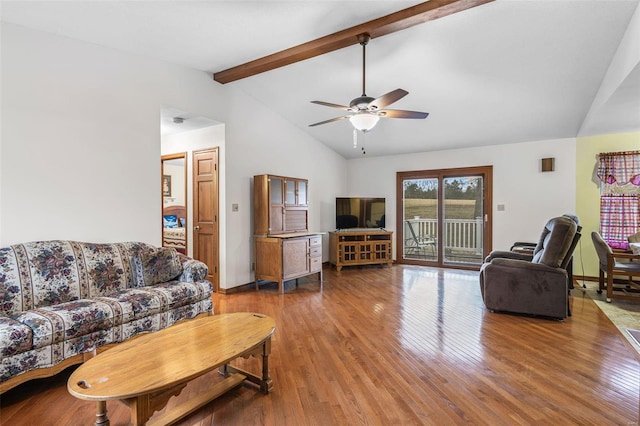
[0,241,213,394]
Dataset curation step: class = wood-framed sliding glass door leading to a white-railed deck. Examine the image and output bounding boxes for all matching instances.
[396,166,492,268]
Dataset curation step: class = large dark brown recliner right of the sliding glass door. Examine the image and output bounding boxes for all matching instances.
[480,215,580,319]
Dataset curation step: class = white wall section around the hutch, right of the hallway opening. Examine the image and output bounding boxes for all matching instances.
[226,85,347,286]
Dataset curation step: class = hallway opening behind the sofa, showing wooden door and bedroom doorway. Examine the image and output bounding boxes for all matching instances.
[160,107,225,292]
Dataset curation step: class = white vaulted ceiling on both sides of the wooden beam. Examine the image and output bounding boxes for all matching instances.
[1,0,640,158]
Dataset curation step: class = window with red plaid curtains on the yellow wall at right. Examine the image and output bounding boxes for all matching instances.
[597,151,640,250]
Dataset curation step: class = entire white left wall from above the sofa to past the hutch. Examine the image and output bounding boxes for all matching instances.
[0,23,346,288]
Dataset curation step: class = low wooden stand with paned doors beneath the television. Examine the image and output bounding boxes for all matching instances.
[329,229,393,271]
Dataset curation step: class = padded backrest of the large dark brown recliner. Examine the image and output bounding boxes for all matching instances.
[531,216,579,268]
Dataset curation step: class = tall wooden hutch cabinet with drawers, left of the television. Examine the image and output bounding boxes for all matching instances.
[253,175,322,292]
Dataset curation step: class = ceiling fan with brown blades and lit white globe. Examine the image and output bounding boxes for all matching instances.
[309,34,429,132]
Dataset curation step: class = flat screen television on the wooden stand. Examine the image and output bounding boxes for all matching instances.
[336,197,385,230]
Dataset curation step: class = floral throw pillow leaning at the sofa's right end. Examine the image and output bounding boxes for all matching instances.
[131,247,182,287]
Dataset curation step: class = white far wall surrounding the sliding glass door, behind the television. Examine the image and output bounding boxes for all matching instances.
[347,139,576,256]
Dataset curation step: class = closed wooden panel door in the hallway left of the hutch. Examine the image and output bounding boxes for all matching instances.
[193,148,220,292]
